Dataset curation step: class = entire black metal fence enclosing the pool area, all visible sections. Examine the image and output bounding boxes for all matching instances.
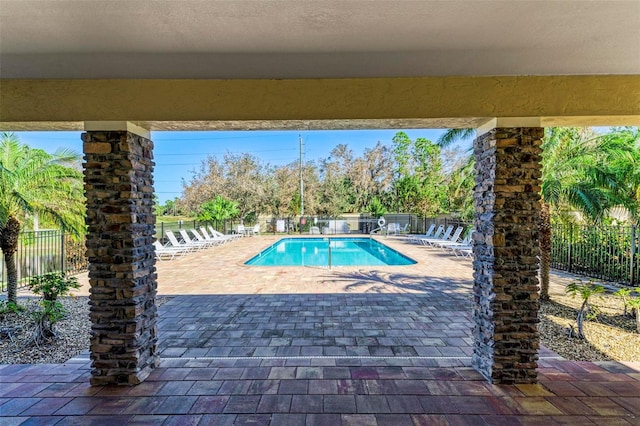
[0,221,640,291]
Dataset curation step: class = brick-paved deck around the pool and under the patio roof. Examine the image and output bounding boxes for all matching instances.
[5,235,640,426]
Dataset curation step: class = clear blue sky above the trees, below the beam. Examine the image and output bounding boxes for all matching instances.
[16,129,443,203]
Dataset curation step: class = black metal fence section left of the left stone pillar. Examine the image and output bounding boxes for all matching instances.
[0,230,88,291]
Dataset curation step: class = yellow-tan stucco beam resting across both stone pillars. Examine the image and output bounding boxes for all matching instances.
[0,75,640,130]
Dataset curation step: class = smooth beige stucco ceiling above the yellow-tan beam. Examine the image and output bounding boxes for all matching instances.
[0,0,640,79]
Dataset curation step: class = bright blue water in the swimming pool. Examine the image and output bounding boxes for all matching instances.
[245,238,416,266]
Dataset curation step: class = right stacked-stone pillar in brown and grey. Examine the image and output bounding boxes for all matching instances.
[473,128,544,383]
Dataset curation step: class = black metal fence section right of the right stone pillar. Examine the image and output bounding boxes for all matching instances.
[551,225,640,286]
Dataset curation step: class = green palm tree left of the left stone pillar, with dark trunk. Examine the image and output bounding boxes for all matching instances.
[0,133,84,304]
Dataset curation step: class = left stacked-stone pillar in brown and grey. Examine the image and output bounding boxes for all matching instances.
[82,131,159,385]
